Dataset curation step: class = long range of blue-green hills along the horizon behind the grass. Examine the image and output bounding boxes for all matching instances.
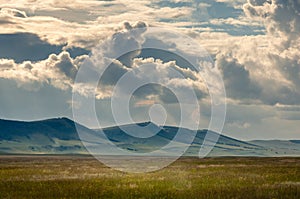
[0,118,300,156]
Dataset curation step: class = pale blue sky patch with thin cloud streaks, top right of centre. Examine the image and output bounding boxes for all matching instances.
[152,0,265,36]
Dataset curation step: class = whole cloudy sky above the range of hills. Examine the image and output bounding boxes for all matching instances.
[0,0,300,140]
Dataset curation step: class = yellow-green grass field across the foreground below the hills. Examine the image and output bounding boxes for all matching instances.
[0,156,300,199]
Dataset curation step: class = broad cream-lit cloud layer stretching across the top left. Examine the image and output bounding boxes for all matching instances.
[0,0,191,49]
